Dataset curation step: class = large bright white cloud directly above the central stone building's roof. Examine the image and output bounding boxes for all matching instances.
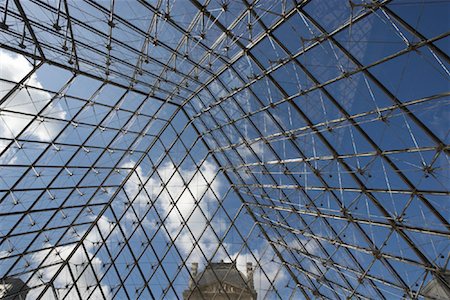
[146,161,221,262]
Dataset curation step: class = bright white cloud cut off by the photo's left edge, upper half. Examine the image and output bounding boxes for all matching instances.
[0,51,66,146]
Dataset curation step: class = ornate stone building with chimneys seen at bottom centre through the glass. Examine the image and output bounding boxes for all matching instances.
[183,261,257,300]
